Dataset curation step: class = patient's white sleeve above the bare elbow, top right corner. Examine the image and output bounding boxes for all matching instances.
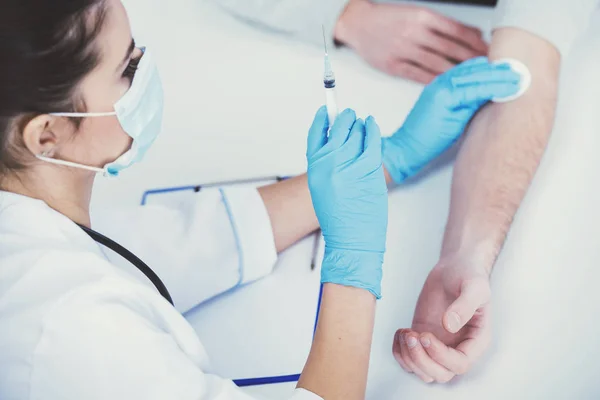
[494,0,599,56]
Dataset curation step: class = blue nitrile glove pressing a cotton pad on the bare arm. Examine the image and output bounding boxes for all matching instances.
[382,57,520,183]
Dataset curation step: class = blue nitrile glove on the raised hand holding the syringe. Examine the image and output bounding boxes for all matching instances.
[306,107,388,298]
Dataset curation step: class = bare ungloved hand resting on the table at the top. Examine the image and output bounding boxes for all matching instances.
[334,0,488,83]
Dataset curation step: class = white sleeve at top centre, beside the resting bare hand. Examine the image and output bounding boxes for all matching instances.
[213,0,349,47]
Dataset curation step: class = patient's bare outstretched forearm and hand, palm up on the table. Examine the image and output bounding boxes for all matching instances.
[394,28,560,382]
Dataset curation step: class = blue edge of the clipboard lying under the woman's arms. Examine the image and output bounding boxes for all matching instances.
[140,180,323,387]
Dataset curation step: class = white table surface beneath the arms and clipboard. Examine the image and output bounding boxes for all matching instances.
[94,0,600,399]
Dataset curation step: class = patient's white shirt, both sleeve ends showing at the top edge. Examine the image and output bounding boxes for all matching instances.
[213,0,598,55]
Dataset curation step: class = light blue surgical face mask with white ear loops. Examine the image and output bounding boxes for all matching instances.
[36,49,164,176]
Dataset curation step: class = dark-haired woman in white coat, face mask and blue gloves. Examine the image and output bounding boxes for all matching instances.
[0,0,519,400]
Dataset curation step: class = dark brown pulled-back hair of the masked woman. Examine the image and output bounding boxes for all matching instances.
[0,0,106,180]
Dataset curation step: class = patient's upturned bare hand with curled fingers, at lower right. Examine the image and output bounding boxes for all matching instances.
[393,263,491,383]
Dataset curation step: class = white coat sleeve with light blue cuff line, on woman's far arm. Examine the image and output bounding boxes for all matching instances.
[93,187,277,313]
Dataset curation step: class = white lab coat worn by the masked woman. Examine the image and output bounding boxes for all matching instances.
[0,188,320,400]
